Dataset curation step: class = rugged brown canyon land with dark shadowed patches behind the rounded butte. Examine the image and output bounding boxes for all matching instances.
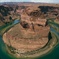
[0,3,59,26]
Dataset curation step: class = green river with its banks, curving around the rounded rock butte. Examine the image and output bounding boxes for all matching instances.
[0,20,59,59]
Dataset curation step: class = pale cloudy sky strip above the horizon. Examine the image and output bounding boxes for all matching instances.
[0,0,59,3]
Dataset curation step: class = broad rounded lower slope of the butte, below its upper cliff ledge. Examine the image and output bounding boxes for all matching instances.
[3,22,50,55]
